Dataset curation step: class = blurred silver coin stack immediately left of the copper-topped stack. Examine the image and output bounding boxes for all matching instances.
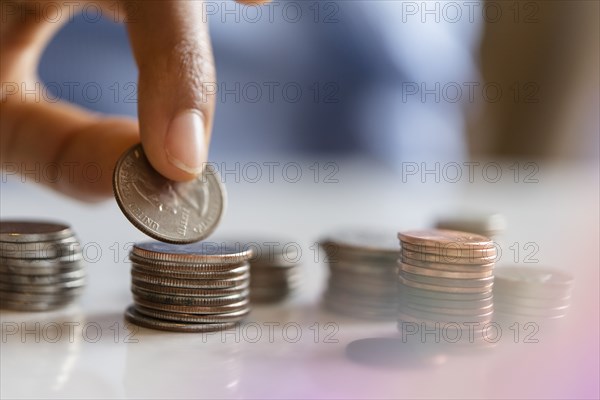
[321,230,399,319]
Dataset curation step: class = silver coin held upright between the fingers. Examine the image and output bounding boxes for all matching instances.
[113,144,225,243]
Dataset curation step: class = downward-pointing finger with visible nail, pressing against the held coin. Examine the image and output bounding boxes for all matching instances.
[123,1,216,181]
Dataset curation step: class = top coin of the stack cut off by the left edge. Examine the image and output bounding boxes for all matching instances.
[0,220,73,243]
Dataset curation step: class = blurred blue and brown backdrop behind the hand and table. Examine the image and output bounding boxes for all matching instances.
[40,1,600,167]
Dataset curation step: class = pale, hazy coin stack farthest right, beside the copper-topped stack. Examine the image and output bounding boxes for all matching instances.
[494,266,573,322]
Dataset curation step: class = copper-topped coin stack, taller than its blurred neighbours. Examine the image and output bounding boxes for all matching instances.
[398,229,496,342]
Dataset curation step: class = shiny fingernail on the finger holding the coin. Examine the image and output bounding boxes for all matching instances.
[165,110,207,175]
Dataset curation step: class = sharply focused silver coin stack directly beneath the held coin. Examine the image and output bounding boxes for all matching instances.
[125,241,252,332]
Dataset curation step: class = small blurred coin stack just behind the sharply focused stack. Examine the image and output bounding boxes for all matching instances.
[243,240,301,303]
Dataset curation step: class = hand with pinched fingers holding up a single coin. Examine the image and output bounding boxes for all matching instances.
[0,0,264,201]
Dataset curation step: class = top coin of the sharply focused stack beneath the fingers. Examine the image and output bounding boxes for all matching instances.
[131,241,252,264]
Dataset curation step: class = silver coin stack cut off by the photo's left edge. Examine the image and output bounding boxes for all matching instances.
[0,221,85,311]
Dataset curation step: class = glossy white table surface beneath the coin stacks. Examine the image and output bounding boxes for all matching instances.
[0,160,600,399]
